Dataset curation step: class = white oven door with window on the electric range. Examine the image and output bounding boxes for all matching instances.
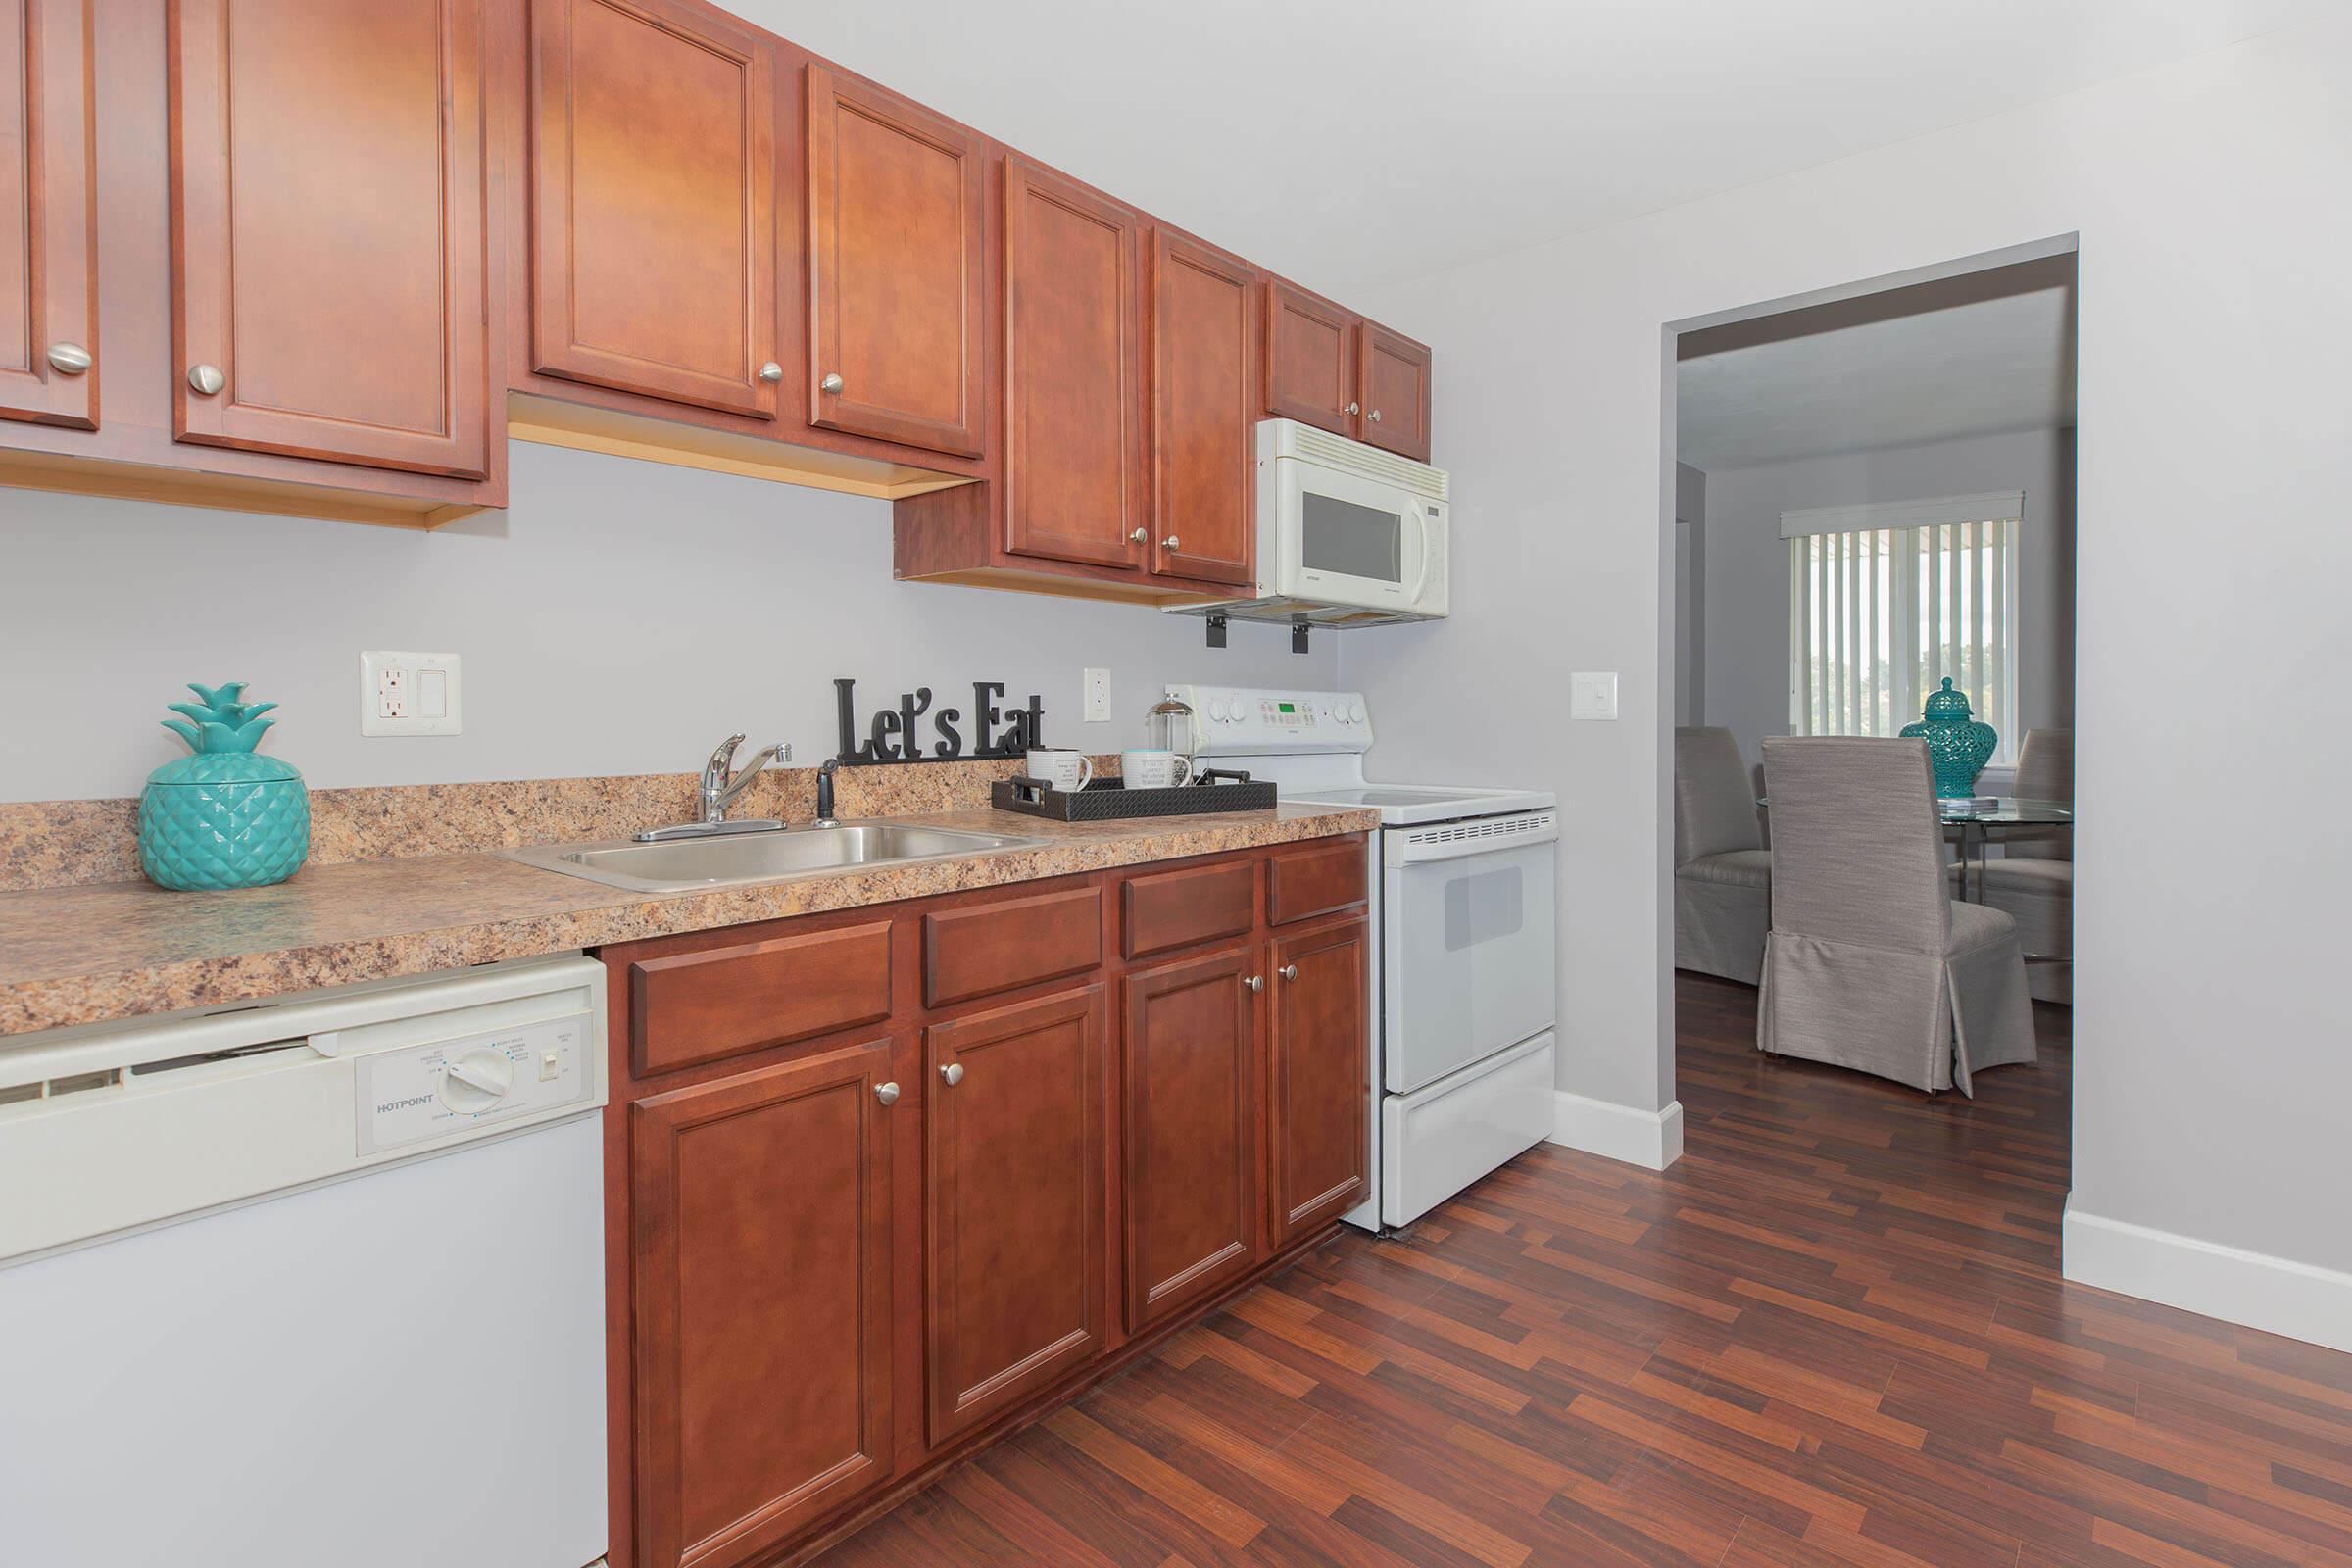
[1381,811,1559,1093]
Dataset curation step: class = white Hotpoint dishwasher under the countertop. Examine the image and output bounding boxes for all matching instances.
[0,956,607,1568]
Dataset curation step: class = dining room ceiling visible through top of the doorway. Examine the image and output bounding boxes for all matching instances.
[1675,254,2075,472]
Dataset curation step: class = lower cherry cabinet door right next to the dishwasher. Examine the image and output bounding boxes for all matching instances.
[628,1039,906,1568]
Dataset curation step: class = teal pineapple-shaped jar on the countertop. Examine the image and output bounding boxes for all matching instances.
[139,682,311,891]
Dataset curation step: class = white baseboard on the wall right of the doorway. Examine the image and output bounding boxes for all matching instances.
[2063,1203,2352,1349]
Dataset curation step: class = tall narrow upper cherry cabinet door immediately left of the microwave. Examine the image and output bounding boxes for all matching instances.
[1151,230,1260,585]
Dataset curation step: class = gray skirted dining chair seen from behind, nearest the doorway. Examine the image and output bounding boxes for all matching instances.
[1757,736,2036,1093]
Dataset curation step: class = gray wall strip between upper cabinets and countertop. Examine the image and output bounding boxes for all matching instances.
[0,442,1334,800]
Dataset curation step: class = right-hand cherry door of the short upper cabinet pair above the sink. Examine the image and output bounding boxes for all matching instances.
[809,64,986,456]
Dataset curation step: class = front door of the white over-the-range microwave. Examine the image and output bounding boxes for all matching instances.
[1265,459,1442,612]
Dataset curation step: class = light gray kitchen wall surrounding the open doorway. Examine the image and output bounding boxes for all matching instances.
[1343,7,2352,1269]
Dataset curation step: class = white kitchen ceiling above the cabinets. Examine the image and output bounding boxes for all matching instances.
[757,0,2324,296]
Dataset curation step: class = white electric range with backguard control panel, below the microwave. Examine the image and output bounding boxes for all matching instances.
[1166,686,1559,1230]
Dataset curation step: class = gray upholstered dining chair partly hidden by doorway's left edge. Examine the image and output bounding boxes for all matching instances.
[1675,729,1771,985]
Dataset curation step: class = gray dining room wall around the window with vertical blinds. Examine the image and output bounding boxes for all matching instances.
[1705,430,2075,761]
